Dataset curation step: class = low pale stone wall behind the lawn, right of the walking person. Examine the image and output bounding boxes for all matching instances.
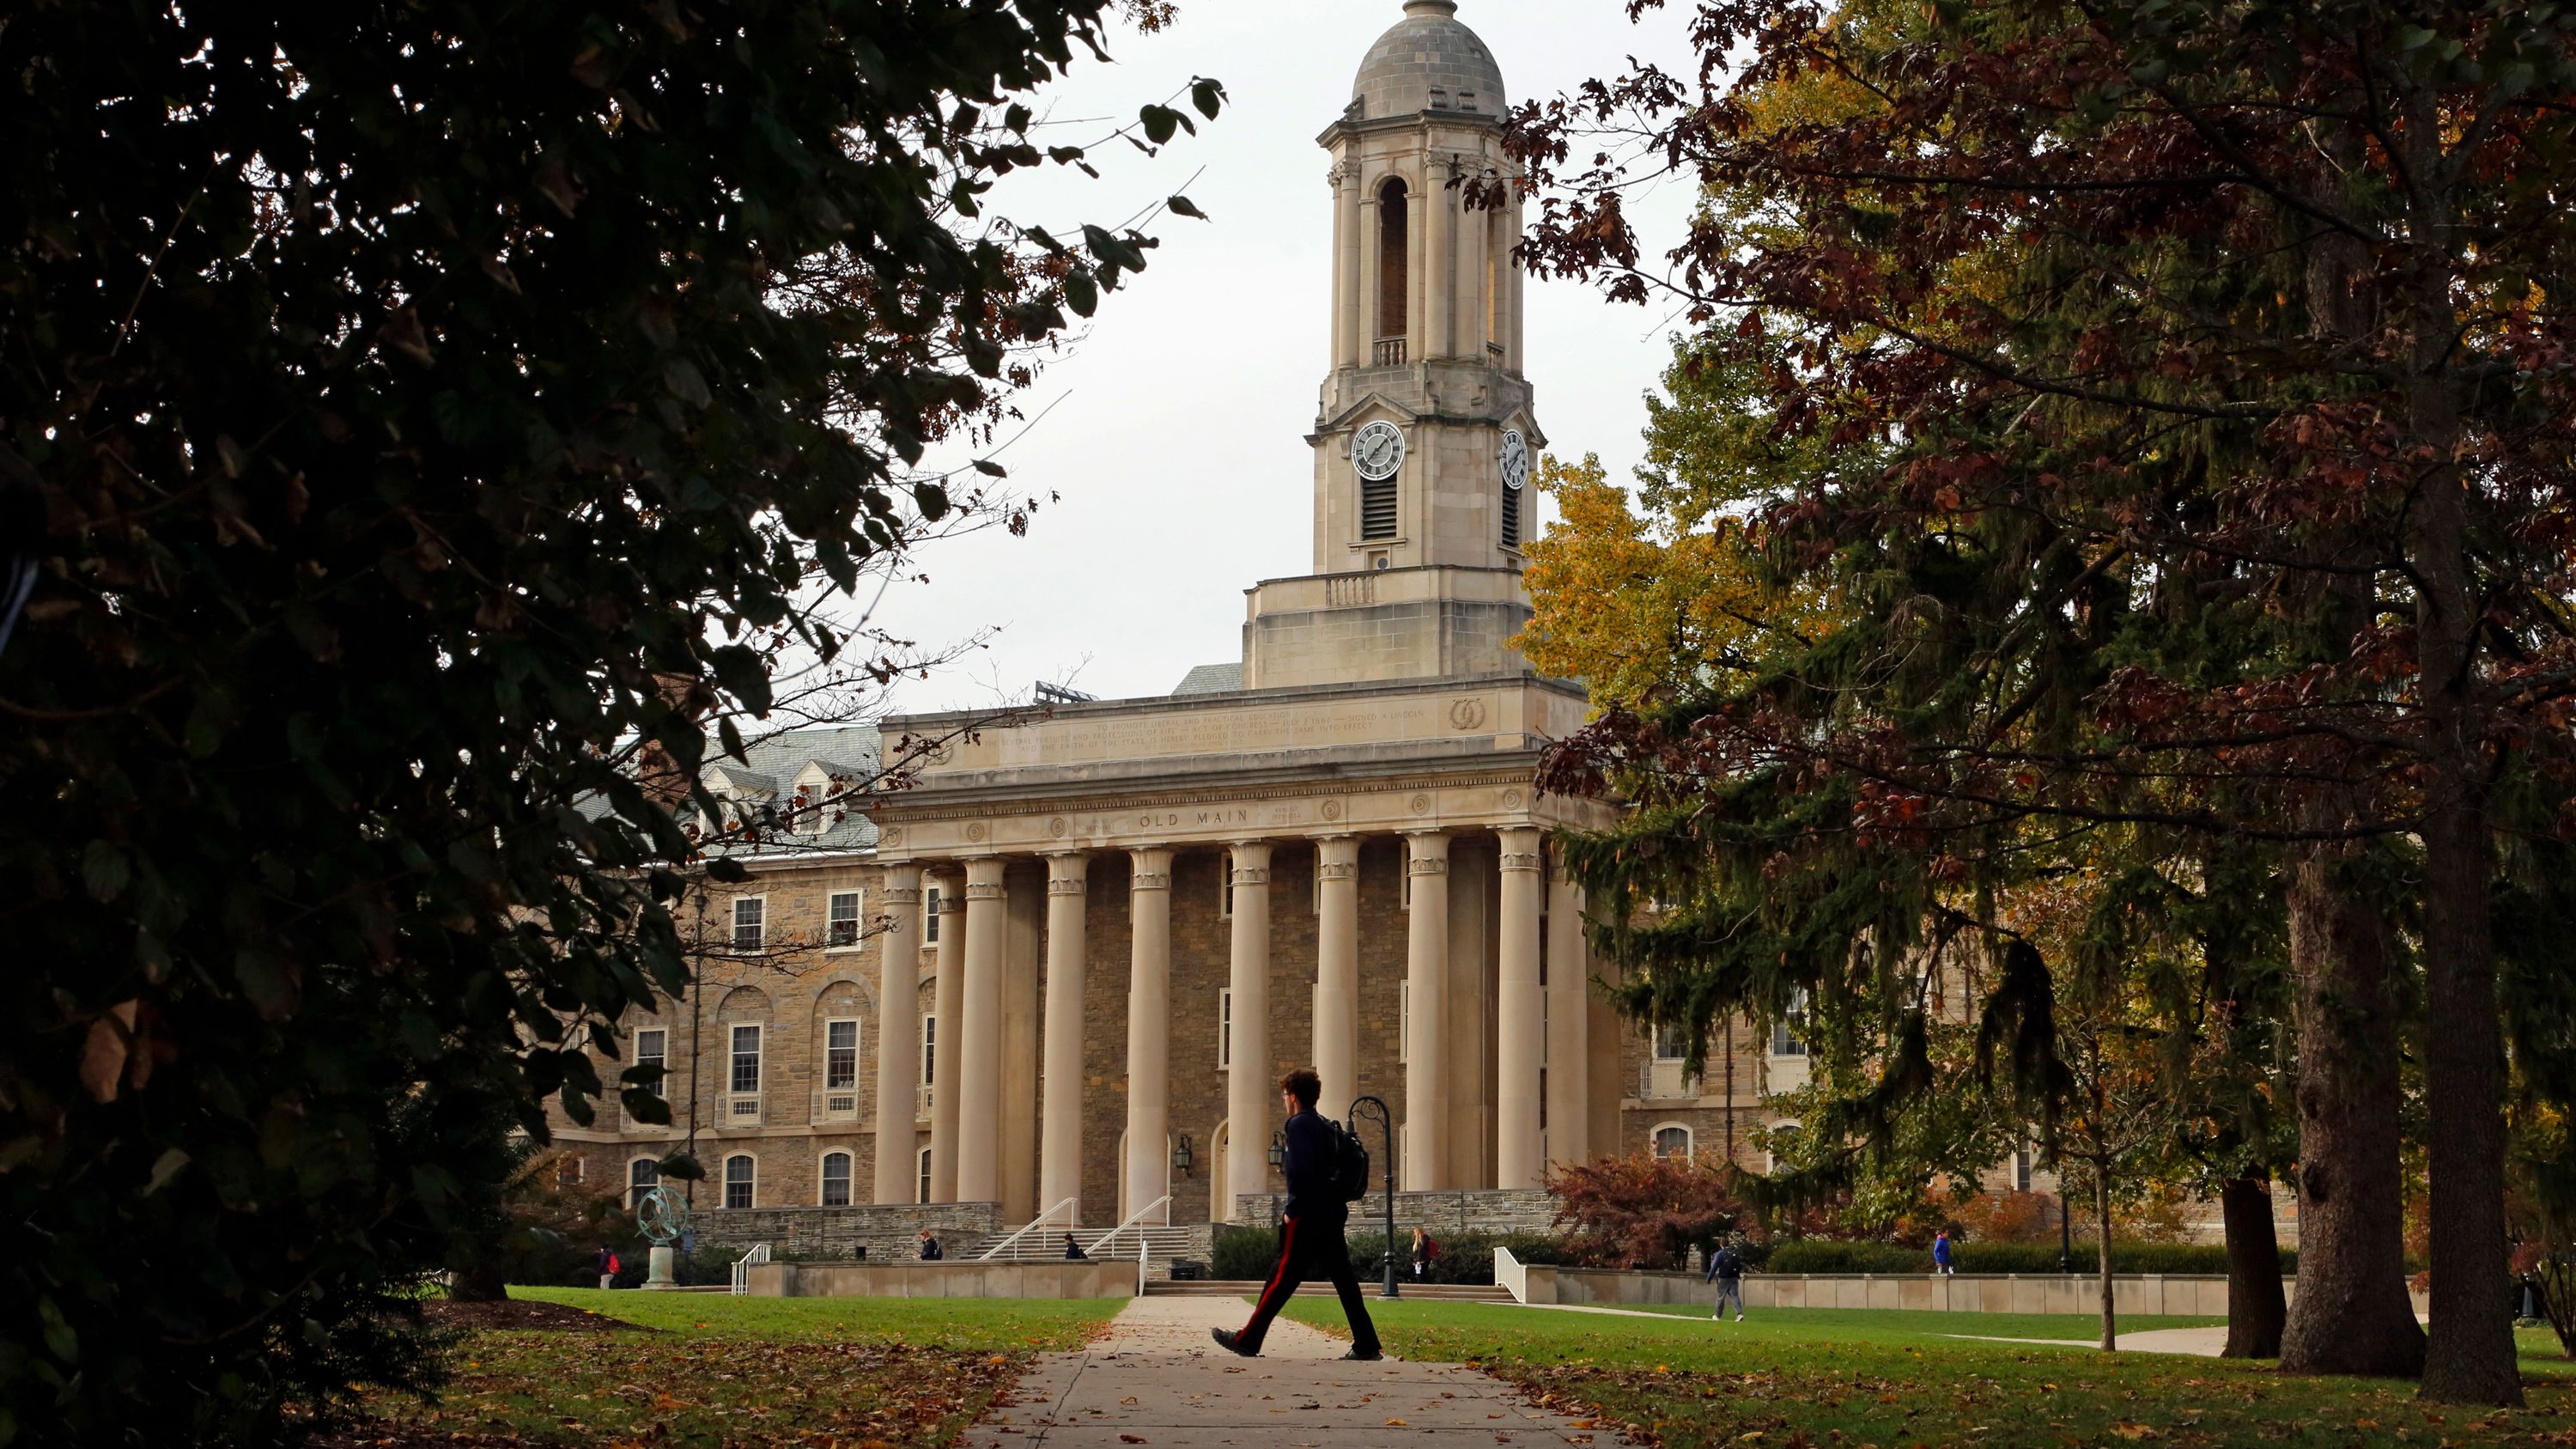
[1497,1263,2295,1318]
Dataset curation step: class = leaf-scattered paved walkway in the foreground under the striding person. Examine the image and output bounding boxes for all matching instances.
[963,1297,1615,1449]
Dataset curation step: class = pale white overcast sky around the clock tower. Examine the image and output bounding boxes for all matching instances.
[881,0,1690,709]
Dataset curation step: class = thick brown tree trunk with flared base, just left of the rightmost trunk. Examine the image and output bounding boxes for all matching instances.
[2280,835,2424,1379]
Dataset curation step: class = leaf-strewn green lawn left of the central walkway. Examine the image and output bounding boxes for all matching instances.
[327,1289,1123,1449]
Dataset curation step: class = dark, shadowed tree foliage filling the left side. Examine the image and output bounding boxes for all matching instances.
[0,0,1221,1444]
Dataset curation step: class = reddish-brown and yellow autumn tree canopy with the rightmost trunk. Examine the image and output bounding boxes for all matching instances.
[1512,0,2576,1403]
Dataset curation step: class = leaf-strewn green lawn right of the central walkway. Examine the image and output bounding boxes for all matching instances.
[1288,1300,2576,1449]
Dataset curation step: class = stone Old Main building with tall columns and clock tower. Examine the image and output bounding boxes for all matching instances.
[562,0,1803,1227]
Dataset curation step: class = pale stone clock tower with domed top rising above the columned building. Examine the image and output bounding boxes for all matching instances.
[1244,0,1546,688]
